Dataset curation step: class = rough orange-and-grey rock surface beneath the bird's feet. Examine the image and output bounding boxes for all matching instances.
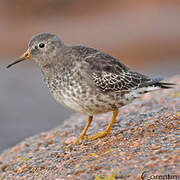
[0,76,180,180]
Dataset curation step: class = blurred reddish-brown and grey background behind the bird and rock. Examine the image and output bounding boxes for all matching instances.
[0,0,180,151]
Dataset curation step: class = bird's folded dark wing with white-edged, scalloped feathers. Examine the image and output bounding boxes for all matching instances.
[74,46,157,91]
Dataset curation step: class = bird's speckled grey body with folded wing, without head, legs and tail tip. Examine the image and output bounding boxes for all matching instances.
[42,46,170,115]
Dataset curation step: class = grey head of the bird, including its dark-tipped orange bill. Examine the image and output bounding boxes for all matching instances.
[7,33,65,68]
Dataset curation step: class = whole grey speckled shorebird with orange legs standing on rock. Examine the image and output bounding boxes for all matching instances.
[8,33,172,142]
